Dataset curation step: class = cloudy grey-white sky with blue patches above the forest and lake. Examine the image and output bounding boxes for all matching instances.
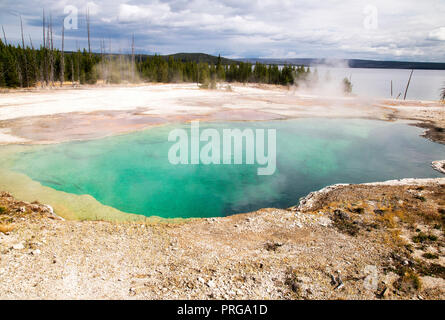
[0,0,445,62]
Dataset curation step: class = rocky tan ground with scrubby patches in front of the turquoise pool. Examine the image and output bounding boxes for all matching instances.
[0,178,445,299]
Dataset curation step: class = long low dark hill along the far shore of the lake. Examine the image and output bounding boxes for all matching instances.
[241,58,445,70]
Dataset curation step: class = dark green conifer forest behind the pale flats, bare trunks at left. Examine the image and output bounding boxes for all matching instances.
[0,35,310,88]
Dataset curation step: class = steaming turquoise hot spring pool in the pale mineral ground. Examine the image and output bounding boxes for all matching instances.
[13,119,445,218]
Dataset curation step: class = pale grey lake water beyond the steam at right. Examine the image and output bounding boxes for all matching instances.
[311,66,445,100]
